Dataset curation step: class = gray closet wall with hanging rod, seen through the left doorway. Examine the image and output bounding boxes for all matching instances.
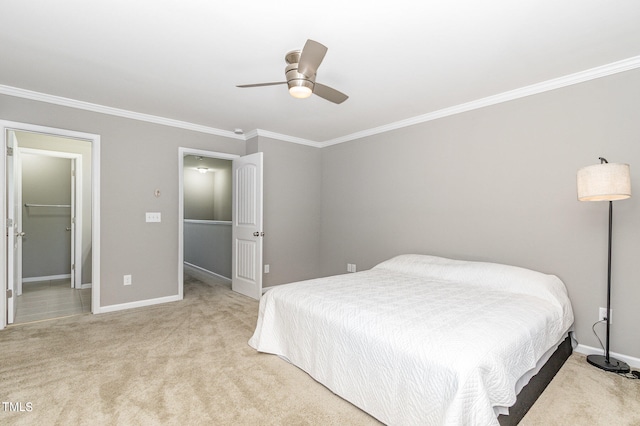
[21,154,71,278]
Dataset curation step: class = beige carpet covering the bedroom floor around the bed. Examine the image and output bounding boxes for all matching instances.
[0,279,640,425]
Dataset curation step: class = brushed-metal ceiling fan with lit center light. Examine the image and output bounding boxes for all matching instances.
[236,40,349,104]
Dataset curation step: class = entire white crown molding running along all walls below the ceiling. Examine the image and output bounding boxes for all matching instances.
[0,56,640,148]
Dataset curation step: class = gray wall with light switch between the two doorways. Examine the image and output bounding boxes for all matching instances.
[0,95,246,306]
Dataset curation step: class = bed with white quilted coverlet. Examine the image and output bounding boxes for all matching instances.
[249,255,573,425]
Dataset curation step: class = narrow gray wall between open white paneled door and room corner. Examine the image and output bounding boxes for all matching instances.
[247,137,321,287]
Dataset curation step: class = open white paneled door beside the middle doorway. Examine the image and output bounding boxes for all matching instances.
[231,152,264,299]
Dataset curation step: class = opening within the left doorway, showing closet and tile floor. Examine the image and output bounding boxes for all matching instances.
[13,148,85,324]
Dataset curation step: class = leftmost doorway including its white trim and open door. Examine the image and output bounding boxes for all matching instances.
[0,121,100,329]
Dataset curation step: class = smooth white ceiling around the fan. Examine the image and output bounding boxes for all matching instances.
[0,0,640,143]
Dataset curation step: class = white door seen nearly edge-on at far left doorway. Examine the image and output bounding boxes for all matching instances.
[6,131,24,324]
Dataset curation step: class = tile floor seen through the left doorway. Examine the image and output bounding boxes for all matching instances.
[14,279,91,324]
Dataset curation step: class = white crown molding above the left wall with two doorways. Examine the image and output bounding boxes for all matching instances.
[0,84,245,140]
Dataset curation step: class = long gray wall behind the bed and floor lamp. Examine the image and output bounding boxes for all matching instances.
[321,70,640,357]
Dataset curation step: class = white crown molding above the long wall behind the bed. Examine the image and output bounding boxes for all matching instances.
[322,56,640,147]
